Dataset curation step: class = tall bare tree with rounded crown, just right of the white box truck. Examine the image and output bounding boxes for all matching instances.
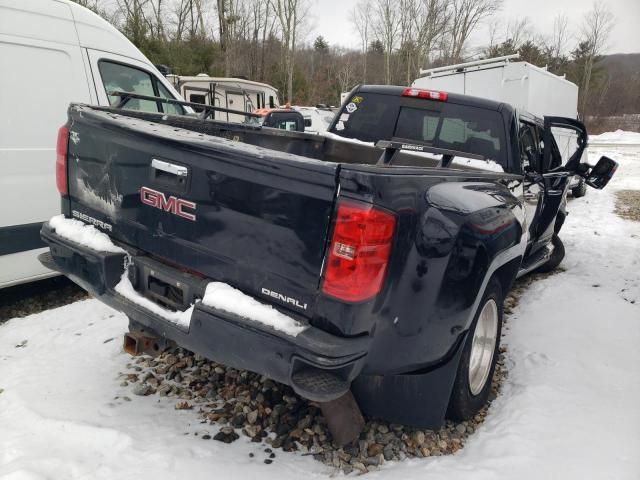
[580,0,615,118]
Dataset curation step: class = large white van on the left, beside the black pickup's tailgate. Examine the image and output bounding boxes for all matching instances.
[0,0,182,288]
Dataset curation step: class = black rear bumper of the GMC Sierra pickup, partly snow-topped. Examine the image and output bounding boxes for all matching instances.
[40,223,370,402]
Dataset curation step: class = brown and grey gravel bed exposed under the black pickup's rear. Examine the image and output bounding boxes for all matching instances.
[119,269,561,474]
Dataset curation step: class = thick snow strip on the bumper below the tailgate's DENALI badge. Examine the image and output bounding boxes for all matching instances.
[202,282,307,337]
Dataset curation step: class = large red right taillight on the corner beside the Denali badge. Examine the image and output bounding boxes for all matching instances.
[322,201,396,302]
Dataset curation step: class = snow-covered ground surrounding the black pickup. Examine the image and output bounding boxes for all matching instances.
[0,135,640,480]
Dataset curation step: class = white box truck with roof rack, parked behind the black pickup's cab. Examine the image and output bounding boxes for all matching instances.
[411,54,586,197]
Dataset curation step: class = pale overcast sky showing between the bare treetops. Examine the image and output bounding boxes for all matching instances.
[306,0,640,53]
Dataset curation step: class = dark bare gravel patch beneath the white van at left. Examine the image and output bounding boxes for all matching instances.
[0,277,88,324]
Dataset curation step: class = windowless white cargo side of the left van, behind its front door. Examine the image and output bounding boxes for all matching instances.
[0,1,91,288]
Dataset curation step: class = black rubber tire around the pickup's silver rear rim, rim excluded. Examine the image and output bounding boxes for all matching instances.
[447,278,503,421]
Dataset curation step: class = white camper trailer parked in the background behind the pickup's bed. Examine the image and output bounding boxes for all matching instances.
[167,73,280,123]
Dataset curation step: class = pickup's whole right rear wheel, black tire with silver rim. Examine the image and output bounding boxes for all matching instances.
[447,278,503,421]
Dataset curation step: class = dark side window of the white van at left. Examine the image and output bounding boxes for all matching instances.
[98,60,184,115]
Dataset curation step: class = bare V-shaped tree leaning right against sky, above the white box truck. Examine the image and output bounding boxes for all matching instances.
[448,0,502,61]
